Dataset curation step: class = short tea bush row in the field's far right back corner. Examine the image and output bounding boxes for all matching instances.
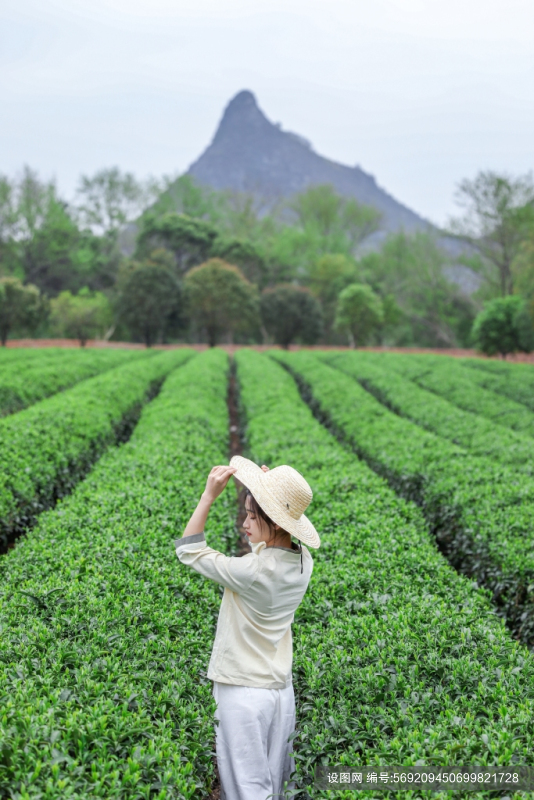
[462,358,534,411]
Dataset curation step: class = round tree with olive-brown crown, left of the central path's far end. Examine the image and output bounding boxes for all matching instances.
[184,258,259,347]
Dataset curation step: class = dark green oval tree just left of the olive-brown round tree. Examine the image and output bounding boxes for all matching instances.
[118,260,183,347]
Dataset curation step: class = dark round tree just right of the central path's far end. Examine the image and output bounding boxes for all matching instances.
[261,283,322,349]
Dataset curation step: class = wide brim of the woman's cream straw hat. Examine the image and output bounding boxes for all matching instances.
[230,456,321,549]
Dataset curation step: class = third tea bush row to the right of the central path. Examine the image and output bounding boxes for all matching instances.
[321,351,534,475]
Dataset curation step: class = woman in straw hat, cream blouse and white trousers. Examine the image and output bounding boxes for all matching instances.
[176,456,321,800]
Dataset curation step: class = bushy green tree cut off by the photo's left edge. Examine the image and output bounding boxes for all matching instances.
[0,276,48,347]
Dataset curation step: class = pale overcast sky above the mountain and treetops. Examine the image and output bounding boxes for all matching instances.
[0,0,534,224]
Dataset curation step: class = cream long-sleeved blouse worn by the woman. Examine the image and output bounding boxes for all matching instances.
[175,533,313,689]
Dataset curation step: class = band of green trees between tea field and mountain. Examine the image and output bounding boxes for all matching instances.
[0,168,534,353]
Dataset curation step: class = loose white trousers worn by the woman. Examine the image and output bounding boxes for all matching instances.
[213,681,295,800]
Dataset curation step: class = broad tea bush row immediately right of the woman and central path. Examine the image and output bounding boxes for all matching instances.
[235,350,534,800]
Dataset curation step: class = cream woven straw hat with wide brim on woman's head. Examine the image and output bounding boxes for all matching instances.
[230,456,321,548]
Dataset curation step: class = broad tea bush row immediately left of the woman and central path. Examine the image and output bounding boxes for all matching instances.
[0,350,236,800]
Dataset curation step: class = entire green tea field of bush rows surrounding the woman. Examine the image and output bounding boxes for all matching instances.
[0,349,534,800]
